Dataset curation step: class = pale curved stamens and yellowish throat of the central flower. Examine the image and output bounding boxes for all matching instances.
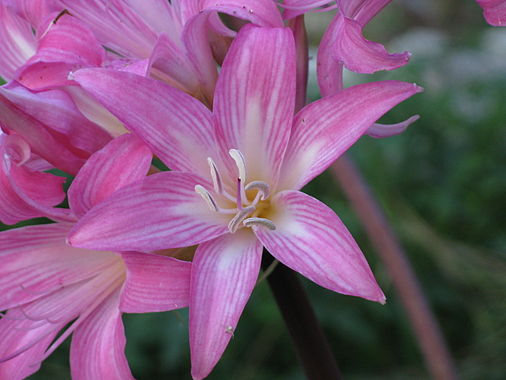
[195,149,276,233]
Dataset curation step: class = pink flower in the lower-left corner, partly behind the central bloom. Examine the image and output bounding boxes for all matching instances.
[0,135,190,380]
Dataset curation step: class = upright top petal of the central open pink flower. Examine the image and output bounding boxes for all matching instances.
[214,25,296,184]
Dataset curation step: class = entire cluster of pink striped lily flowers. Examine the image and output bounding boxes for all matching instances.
[9,0,505,380]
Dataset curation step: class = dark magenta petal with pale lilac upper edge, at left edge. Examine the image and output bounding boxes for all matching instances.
[0,82,111,155]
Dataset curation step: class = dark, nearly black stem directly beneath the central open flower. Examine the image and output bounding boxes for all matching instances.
[262,250,341,380]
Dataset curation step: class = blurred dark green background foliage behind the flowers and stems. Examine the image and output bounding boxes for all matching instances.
[1,0,506,380]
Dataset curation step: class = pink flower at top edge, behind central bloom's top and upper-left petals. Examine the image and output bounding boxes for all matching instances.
[55,0,283,104]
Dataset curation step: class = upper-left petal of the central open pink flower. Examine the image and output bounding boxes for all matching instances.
[74,69,216,177]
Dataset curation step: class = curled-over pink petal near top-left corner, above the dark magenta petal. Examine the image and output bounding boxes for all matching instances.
[19,14,105,90]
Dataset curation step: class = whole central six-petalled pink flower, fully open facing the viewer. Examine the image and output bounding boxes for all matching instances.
[69,26,420,379]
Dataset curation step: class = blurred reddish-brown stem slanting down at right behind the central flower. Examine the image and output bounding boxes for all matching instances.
[331,156,458,380]
